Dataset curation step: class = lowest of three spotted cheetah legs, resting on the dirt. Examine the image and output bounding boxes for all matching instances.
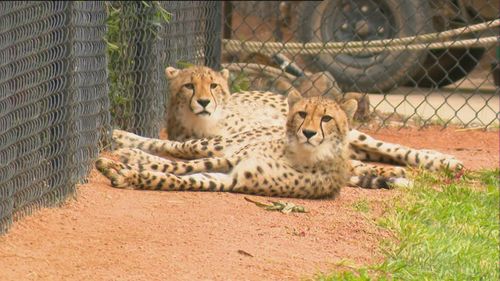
[96,158,235,191]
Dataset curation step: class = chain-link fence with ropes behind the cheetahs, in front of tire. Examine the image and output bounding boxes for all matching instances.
[222,0,500,128]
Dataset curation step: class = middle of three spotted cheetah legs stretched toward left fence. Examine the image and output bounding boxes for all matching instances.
[115,148,239,175]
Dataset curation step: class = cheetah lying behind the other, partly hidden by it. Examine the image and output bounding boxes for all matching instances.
[155,66,463,171]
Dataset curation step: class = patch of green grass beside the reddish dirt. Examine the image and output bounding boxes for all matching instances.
[315,169,500,280]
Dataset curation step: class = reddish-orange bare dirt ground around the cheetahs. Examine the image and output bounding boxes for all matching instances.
[0,128,499,280]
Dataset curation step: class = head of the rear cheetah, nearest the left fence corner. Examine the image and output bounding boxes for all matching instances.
[165,66,230,118]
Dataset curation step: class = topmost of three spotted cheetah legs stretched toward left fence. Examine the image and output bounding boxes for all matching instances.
[113,130,224,159]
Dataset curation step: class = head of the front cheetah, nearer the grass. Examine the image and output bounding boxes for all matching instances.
[287,91,357,159]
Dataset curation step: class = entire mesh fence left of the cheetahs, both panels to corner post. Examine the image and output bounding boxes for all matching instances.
[0,1,222,232]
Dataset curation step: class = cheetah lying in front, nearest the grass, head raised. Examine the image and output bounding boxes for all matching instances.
[96,93,403,198]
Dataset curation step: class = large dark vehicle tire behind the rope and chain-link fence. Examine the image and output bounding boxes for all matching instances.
[297,0,433,92]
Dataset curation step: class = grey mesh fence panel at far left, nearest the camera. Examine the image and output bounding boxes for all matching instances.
[0,1,110,233]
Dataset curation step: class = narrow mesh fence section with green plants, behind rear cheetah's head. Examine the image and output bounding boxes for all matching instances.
[110,1,221,137]
